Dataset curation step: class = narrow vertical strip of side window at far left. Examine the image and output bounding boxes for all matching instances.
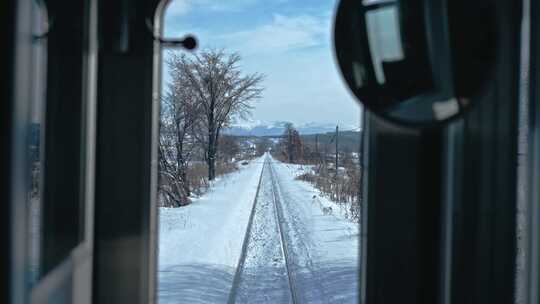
[26,1,49,285]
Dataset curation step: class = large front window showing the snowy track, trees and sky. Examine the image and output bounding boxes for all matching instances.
[157,0,362,303]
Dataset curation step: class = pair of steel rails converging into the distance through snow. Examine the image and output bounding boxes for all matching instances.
[228,156,298,304]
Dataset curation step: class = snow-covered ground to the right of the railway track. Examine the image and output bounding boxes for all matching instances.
[272,161,359,303]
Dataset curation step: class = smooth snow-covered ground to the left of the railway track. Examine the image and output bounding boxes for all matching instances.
[158,159,262,304]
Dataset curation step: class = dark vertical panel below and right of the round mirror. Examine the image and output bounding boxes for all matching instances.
[443,1,523,304]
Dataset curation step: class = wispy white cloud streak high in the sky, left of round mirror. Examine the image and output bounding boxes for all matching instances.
[217,14,330,55]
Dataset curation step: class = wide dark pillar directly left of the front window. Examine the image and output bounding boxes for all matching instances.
[93,0,162,304]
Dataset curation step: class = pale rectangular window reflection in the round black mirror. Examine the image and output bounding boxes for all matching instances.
[366,6,403,84]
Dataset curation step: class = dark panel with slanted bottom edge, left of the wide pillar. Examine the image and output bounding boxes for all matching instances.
[32,2,86,276]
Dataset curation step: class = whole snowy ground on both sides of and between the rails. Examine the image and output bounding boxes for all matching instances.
[158,158,359,304]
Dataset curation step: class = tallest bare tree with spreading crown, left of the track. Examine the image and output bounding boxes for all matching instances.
[175,50,263,180]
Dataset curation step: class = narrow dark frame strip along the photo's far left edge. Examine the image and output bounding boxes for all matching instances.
[0,1,32,303]
